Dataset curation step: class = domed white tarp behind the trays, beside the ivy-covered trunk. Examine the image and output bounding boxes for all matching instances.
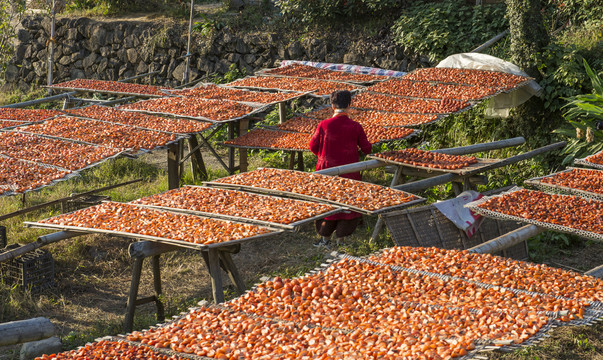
[436,53,542,117]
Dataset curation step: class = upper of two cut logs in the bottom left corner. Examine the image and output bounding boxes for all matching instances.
[0,317,55,346]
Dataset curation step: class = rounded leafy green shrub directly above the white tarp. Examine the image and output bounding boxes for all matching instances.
[392,0,508,61]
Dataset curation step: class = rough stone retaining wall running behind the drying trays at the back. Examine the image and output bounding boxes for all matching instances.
[4,17,424,90]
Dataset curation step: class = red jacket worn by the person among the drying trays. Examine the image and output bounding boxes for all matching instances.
[310,114,372,220]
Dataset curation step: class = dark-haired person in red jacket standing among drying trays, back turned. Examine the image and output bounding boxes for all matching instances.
[310,90,372,247]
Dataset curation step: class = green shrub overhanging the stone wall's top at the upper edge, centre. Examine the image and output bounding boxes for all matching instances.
[276,0,403,24]
